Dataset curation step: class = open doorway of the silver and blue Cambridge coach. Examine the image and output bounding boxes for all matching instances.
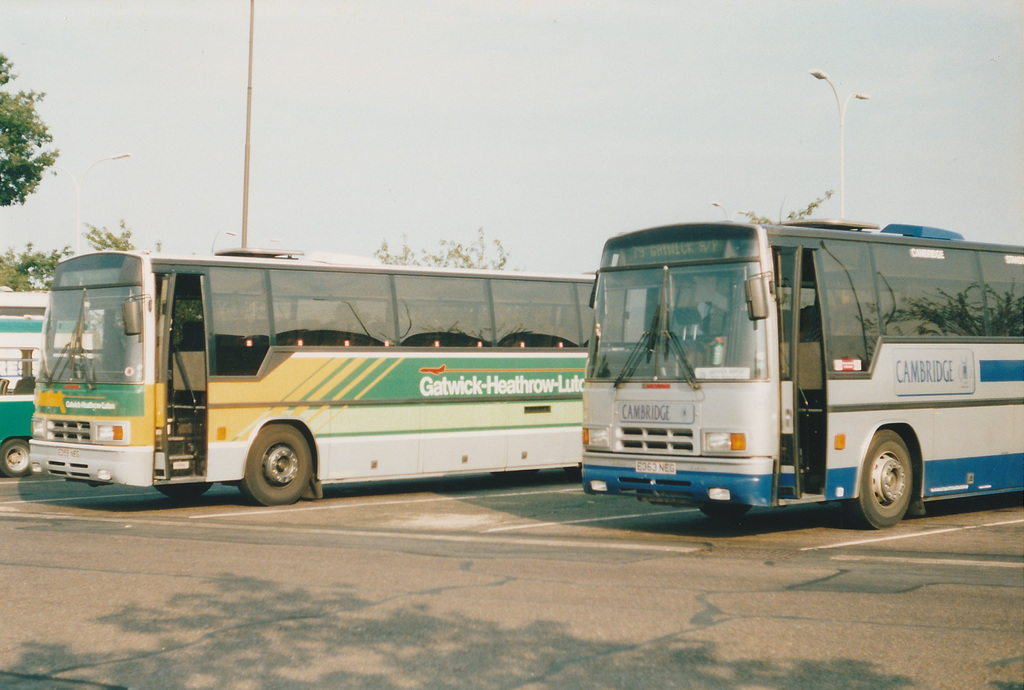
[774,247,826,500]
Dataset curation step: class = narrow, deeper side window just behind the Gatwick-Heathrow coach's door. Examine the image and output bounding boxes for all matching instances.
[210,268,270,376]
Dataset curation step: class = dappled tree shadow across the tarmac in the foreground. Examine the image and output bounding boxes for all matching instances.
[0,576,912,690]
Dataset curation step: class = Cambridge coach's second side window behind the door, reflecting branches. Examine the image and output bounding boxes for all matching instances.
[874,245,985,336]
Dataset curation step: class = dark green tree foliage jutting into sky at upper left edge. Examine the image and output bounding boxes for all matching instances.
[0,54,60,206]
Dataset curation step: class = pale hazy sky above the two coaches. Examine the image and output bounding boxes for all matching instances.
[0,0,1024,273]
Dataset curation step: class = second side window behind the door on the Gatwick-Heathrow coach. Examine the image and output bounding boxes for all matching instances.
[270,270,394,347]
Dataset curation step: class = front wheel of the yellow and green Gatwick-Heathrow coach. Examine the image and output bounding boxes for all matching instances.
[239,425,312,506]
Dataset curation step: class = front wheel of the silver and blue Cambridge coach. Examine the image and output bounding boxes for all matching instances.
[844,430,913,529]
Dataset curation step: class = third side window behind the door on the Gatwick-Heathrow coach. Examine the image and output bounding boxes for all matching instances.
[394,275,494,347]
